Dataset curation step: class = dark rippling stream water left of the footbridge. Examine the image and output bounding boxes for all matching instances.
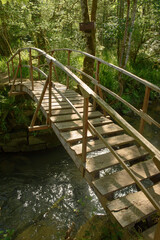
[0,147,103,239]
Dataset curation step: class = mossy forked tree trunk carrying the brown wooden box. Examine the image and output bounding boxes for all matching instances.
[81,0,98,84]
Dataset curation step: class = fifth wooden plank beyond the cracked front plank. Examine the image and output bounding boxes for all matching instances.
[56,116,112,131]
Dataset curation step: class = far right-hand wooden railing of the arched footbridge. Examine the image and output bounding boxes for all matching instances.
[47,48,160,134]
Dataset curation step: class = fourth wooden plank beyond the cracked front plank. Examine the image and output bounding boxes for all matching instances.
[61,123,123,142]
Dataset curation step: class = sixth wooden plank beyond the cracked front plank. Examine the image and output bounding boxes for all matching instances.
[50,111,102,122]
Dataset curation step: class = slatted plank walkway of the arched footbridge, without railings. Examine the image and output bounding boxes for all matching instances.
[15,81,160,239]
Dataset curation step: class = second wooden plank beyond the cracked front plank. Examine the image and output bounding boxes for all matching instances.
[86,145,148,172]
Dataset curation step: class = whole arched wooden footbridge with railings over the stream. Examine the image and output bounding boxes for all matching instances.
[7,48,160,240]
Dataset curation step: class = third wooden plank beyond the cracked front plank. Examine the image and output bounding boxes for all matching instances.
[71,134,134,155]
